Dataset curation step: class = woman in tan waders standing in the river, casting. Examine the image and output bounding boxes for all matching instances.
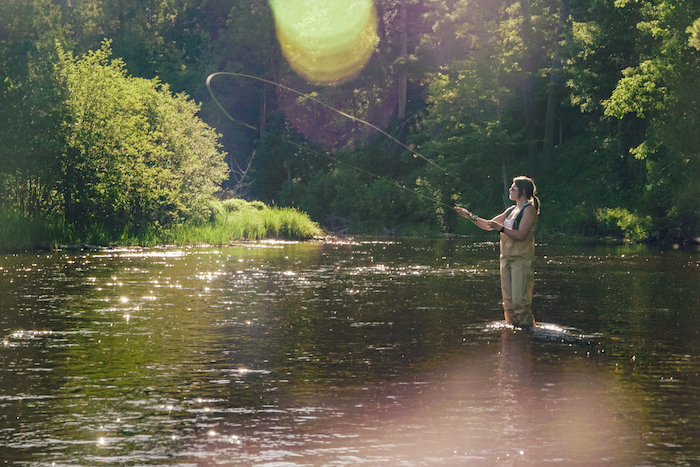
[455,177,540,328]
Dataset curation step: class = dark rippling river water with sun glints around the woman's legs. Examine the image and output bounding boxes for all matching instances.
[0,238,700,466]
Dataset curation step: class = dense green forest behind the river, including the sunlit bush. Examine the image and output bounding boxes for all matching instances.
[0,0,700,247]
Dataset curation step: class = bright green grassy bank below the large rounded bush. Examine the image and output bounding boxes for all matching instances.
[0,199,323,252]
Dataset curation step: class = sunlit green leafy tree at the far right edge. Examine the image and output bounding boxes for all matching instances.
[604,0,700,239]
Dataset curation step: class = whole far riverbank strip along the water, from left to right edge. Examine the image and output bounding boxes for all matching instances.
[0,199,700,253]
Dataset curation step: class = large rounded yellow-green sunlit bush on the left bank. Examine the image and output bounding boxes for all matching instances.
[0,2,228,245]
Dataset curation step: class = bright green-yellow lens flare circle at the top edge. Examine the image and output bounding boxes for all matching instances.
[270,0,379,85]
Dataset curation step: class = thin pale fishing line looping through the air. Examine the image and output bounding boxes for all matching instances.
[206,71,486,209]
